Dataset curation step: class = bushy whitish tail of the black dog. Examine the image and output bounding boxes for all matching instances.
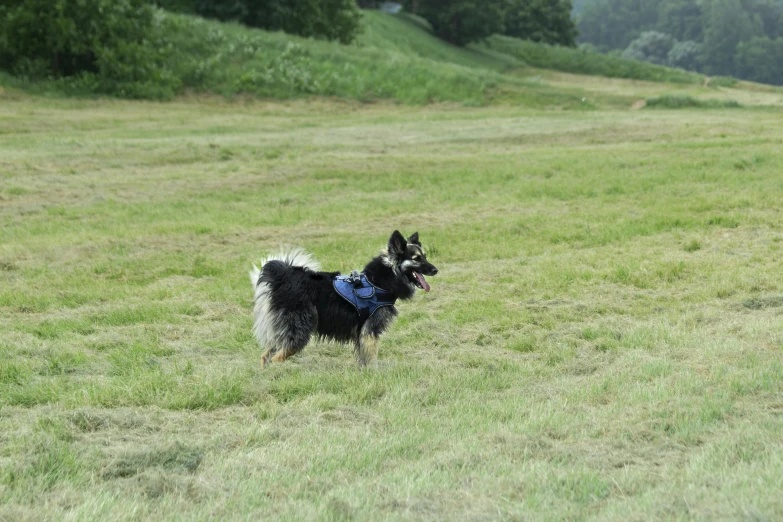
[250,248,321,347]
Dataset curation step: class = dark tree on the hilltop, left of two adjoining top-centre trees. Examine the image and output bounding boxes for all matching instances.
[404,0,507,45]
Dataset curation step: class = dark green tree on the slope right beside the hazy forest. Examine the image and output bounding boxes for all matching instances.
[504,0,577,47]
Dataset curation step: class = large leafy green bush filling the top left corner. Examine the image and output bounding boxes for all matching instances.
[0,0,180,98]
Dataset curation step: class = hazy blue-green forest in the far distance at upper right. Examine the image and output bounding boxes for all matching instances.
[577,0,783,84]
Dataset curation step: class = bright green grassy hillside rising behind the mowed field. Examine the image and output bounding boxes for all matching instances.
[0,7,772,109]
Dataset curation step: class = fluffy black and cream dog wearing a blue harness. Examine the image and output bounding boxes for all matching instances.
[250,230,438,367]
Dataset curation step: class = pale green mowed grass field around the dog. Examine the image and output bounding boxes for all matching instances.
[0,87,783,520]
